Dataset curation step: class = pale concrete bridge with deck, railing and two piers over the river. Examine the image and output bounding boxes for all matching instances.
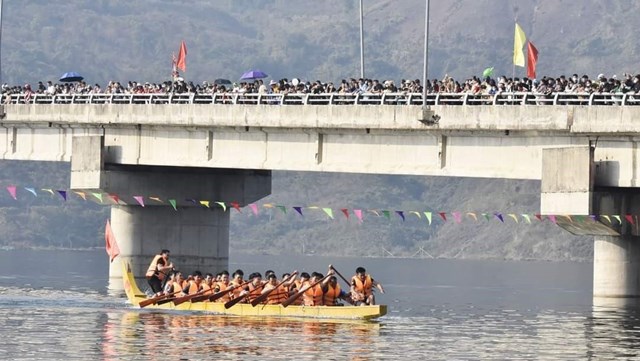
[0,94,640,297]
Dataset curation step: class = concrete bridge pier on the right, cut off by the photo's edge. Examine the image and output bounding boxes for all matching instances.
[540,147,640,299]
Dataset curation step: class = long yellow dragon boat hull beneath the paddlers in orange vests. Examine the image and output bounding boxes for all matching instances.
[122,263,387,320]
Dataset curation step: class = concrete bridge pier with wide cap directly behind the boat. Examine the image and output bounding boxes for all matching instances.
[71,136,271,293]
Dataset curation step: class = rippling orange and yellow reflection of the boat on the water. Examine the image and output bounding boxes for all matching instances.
[102,311,382,360]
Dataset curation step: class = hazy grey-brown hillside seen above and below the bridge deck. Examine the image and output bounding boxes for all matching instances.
[0,0,612,260]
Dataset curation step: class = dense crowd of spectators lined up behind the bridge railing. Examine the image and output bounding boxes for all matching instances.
[1,73,640,100]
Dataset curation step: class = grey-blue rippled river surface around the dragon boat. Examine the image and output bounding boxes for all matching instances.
[0,250,640,360]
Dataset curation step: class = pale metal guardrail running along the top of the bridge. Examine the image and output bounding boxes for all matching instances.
[3,93,640,106]
